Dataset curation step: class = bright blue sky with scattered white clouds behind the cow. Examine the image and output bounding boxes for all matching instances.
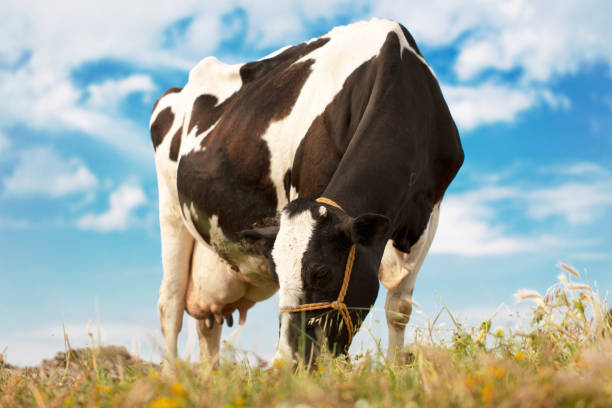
[0,0,612,364]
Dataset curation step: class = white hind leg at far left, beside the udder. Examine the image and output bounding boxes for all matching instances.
[158,170,194,365]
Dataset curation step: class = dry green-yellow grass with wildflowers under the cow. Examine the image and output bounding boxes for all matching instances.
[0,264,612,408]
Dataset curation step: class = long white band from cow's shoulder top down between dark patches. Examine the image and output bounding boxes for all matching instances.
[262,19,433,211]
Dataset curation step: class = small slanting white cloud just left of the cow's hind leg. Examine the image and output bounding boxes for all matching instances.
[77,183,146,232]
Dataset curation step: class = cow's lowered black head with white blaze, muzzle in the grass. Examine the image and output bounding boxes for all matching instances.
[240,199,389,359]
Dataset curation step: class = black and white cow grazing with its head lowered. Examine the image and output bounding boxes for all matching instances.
[150,19,463,360]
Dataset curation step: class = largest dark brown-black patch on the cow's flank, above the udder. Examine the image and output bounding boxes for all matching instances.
[177,39,328,245]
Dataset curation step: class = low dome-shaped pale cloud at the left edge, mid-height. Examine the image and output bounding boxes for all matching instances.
[4,147,98,197]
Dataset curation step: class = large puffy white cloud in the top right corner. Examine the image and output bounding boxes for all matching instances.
[455,1,612,81]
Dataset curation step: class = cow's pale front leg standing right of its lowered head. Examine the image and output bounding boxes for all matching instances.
[382,204,440,363]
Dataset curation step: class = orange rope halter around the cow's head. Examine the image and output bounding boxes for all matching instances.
[280,197,355,350]
